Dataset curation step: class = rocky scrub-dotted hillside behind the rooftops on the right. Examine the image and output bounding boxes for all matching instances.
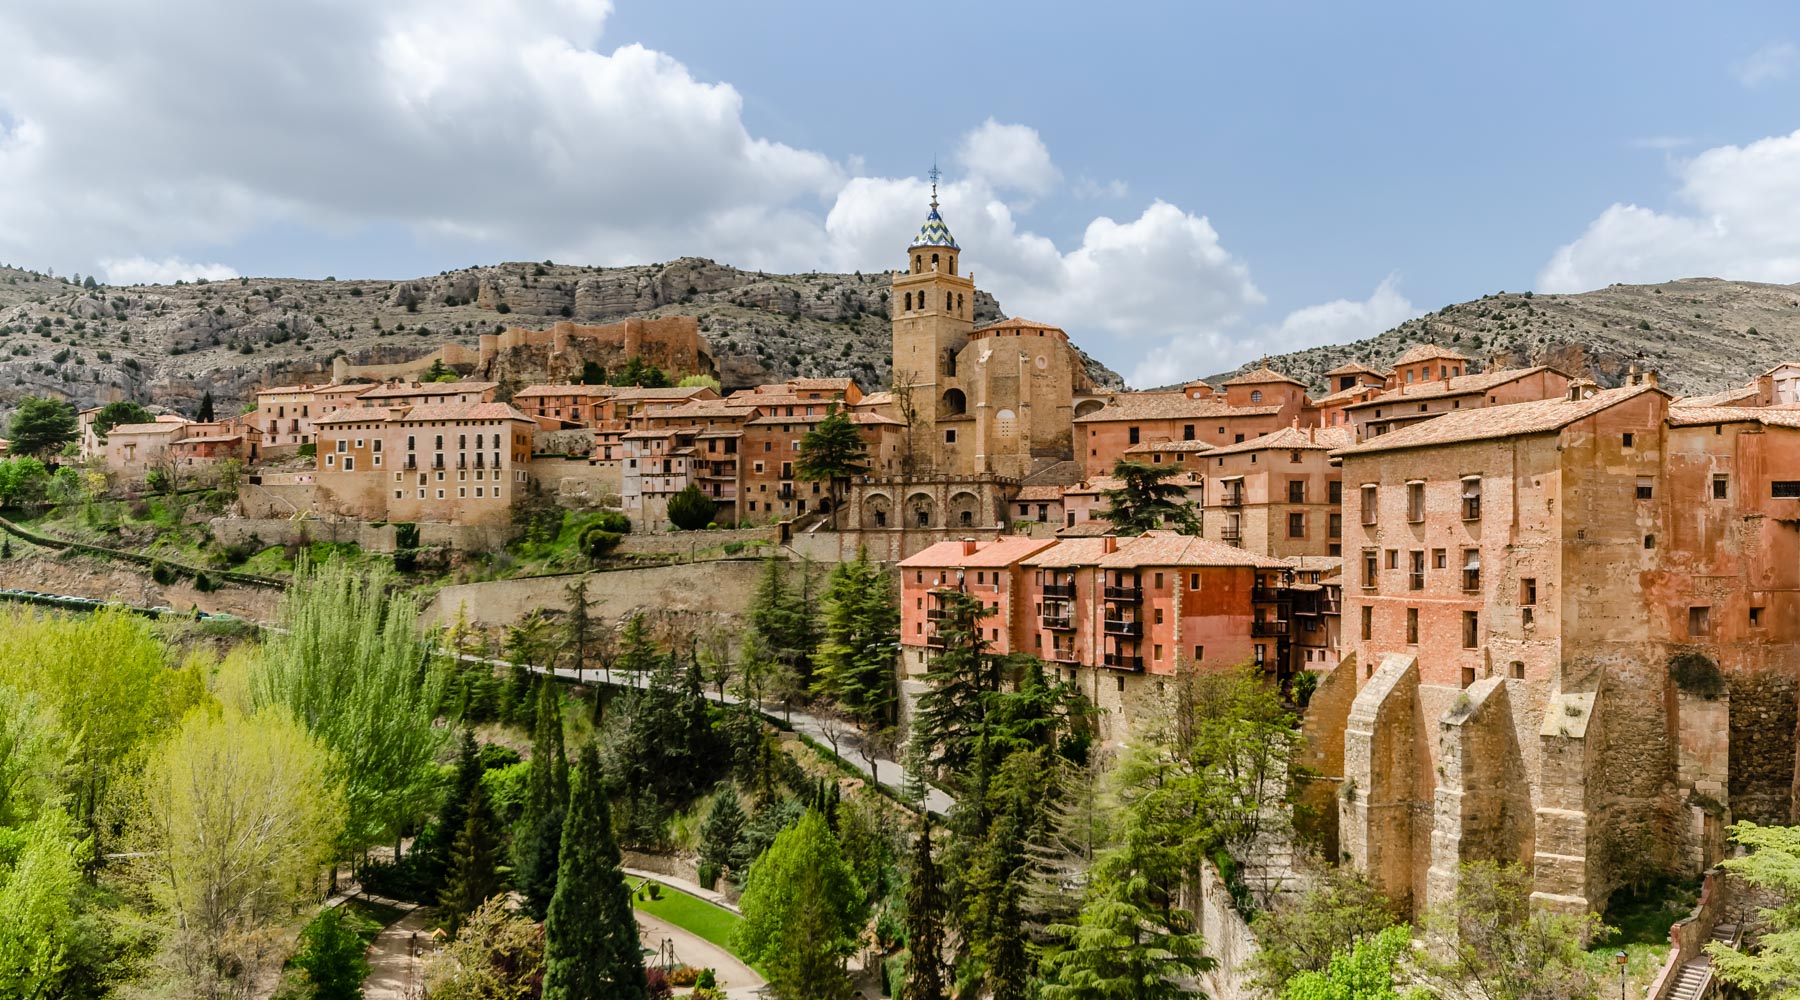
[1208,277,1800,394]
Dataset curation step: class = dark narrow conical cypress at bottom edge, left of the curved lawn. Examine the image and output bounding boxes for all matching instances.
[544,743,646,1000]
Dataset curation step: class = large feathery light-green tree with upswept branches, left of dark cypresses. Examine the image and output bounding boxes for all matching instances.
[252,561,448,854]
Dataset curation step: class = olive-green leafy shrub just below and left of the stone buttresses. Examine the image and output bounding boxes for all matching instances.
[1251,865,1393,995]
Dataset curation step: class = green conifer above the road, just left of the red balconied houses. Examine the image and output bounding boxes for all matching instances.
[814,550,900,728]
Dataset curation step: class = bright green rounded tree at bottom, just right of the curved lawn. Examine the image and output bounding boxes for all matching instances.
[733,811,868,1000]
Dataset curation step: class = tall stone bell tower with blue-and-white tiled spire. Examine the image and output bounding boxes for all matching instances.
[887,165,976,469]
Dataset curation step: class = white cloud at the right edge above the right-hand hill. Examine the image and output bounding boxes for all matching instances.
[1537,131,1800,291]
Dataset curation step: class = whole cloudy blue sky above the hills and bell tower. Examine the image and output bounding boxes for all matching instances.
[0,0,1800,383]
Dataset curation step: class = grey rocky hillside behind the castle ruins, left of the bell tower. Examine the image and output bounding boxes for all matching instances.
[0,257,1121,414]
